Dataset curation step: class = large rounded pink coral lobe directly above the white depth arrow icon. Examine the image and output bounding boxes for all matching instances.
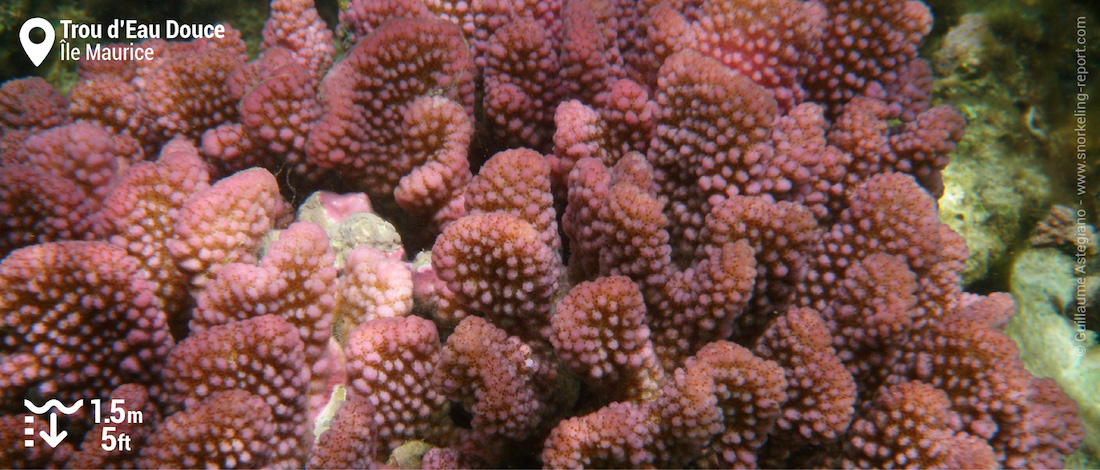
[0,241,172,409]
